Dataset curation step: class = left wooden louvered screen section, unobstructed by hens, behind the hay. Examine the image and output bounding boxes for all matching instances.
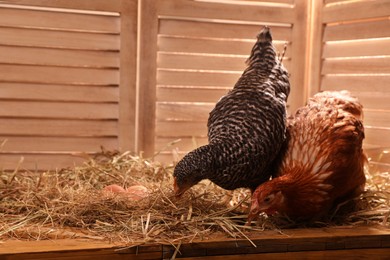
[0,0,137,169]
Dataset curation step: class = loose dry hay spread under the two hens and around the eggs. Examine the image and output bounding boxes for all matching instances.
[0,147,390,245]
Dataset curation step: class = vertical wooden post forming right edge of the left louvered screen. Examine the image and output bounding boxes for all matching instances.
[118,1,138,151]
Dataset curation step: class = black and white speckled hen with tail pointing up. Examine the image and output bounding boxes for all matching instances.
[174,27,290,196]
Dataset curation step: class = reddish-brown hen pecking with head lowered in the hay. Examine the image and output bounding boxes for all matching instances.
[248,91,367,224]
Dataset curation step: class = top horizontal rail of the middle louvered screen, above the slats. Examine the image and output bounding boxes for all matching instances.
[158,0,294,23]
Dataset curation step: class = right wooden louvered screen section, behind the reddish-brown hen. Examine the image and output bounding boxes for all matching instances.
[311,0,390,148]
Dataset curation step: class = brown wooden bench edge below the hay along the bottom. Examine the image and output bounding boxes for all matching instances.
[0,226,390,260]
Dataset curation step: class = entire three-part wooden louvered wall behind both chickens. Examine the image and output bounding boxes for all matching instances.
[0,0,390,169]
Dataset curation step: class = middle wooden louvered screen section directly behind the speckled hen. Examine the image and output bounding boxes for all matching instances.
[140,0,307,161]
